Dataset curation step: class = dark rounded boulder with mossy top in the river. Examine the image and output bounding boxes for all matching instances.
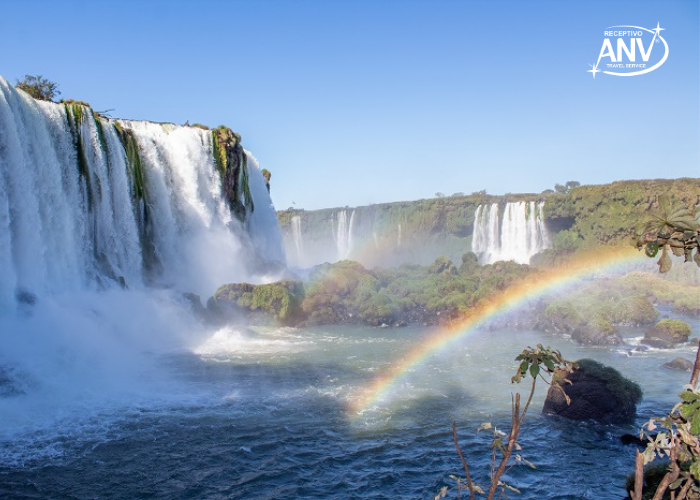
[542,359,642,424]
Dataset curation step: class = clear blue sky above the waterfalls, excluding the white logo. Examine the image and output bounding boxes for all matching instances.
[0,0,700,209]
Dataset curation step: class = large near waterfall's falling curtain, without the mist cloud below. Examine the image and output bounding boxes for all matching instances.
[0,77,284,309]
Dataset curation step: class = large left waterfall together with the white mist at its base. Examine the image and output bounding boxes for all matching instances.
[0,73,285,439]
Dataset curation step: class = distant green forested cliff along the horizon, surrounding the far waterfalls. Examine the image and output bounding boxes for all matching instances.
[278,178,700,267]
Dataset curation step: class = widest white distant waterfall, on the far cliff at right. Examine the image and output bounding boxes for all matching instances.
[472,201,551,264]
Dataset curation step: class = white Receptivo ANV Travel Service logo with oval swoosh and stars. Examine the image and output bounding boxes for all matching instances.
[588,23,668,78]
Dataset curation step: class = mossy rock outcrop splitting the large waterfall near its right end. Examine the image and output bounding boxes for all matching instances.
[212,125,255,221]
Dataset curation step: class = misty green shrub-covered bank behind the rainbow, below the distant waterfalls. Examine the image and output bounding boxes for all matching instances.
[303,254,536,326]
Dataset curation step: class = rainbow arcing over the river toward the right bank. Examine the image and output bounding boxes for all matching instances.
[349,248,648,415]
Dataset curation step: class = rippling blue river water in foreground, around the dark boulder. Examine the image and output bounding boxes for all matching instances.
[0,320,697,499]
